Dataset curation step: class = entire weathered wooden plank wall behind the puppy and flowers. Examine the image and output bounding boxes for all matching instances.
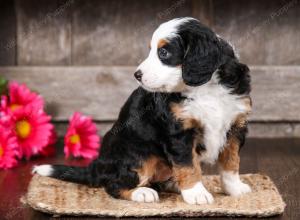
[0,0,300,137]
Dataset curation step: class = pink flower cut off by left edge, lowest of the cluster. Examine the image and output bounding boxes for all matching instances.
[0,124,20,169]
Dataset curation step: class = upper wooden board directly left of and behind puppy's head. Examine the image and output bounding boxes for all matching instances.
[72,0,193,66]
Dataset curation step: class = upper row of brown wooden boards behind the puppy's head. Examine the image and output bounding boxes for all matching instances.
[0,0,300,66]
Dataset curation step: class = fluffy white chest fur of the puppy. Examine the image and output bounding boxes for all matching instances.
[183,74,247,163]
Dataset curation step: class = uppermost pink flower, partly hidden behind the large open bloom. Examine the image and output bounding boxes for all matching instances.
[1,82,44,112]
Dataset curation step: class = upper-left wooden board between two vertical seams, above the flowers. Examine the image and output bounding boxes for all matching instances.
[16,0,74,66]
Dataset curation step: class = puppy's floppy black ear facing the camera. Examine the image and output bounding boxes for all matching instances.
[182,34,223,86]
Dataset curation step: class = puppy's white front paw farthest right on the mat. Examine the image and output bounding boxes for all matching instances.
[222,172,251,197]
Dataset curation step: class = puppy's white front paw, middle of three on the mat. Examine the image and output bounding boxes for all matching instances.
[181,182,214,205]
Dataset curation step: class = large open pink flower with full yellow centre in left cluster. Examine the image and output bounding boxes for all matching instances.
[7,105,54,159]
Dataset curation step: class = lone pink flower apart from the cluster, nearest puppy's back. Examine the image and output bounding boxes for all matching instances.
[64,112,100,159]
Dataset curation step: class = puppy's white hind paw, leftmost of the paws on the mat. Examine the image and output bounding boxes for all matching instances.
[131,187,159,202]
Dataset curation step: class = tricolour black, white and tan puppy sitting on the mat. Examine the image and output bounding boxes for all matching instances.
[33,17,251,204]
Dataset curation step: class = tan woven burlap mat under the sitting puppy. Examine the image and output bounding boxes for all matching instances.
[23,174,285,217]
